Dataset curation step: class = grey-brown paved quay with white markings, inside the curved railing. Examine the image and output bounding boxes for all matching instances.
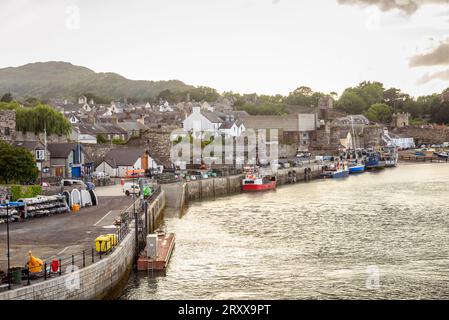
[0,186,132,270]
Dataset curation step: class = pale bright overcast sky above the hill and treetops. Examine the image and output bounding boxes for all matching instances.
[0,0,449,96]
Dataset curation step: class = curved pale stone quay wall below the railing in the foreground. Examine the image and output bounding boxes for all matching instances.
[0,191,165,300]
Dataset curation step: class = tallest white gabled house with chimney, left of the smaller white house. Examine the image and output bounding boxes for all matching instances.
[183,106,224,136]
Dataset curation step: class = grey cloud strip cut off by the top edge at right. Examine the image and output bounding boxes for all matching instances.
[338,0,449,14]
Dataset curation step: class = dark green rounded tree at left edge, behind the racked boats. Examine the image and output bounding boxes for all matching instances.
[0,141,38,184]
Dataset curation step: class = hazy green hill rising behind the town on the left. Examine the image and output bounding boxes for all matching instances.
[0,61,193,100]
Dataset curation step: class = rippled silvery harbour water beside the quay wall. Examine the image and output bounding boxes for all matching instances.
[118,164,449,299]
